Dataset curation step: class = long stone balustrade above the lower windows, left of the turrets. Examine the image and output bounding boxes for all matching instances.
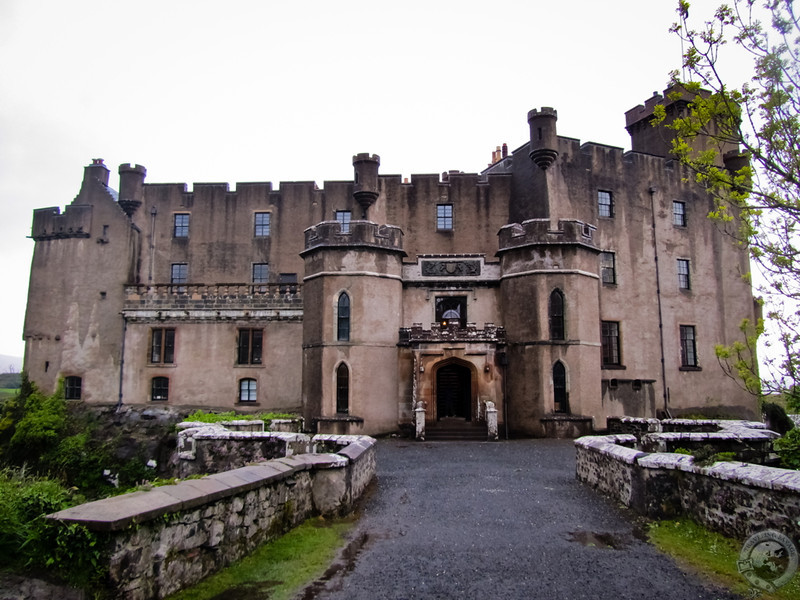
[124,283,303,310]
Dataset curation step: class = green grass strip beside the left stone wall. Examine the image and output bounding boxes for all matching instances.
[168,517,354,600]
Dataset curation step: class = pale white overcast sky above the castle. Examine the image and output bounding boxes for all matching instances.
[0,0,752,356]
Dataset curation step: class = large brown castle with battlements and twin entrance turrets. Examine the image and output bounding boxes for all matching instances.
[24,88,758,436]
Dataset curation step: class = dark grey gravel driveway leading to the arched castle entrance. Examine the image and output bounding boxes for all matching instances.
[303,440,739,600]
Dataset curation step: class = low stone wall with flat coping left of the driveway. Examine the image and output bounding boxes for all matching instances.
[48,436,376,600]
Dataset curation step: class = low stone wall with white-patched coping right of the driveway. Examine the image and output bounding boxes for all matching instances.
[575,422,800,540]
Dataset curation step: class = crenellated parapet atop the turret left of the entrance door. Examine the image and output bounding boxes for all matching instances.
[303,221,403,253]
